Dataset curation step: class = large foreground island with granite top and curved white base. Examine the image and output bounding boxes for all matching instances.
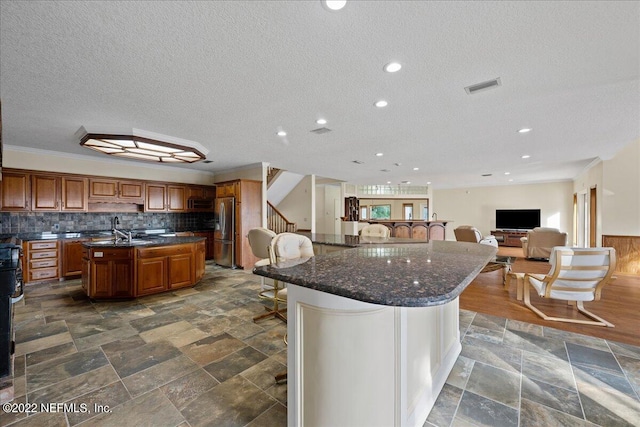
[254,240,496,426]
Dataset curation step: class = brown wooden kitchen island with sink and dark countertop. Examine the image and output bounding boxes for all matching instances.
[82,237,206,299]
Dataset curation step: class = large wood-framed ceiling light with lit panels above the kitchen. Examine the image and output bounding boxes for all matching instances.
[76,126,209,164]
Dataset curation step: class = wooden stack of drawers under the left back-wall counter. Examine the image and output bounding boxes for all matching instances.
[23,240,60,284]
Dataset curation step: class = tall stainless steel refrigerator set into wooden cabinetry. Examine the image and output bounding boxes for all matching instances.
[213,197,236,268]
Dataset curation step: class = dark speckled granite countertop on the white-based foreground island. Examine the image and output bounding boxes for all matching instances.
[253,241,497,307]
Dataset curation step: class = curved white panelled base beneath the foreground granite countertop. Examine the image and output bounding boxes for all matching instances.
[287,284,462,427]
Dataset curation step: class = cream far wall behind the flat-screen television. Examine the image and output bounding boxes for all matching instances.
[432,181,573,242]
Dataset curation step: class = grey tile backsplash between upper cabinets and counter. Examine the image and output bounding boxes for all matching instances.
[0,212,214,234]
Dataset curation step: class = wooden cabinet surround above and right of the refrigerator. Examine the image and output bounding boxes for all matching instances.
[216,179,262,268]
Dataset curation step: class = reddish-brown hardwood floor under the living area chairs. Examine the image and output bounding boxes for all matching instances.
[460,246,640,345]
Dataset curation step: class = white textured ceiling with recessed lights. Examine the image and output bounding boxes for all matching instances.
[0,0,640,188]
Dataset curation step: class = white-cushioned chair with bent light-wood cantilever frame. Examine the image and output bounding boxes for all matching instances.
[524,246,616,328]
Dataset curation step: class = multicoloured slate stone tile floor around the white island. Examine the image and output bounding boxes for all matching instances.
[0,264,640,427]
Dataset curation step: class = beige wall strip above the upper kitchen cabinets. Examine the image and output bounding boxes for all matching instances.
[2,145,213,185]
